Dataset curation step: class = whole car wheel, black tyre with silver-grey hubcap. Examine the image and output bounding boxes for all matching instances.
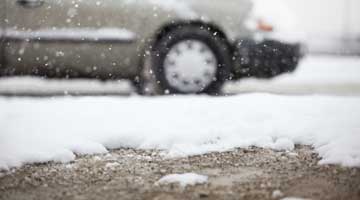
[141,26,231,95]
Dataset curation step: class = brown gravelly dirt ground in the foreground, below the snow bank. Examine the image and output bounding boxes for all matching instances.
[0,146,360,200]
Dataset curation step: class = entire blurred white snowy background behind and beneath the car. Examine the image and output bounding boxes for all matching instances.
[0,0,360,96]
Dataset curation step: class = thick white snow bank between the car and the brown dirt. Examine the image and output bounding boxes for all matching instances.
[0,94,360,169]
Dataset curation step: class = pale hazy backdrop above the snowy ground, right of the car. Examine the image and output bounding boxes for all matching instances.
[253,0,360,56]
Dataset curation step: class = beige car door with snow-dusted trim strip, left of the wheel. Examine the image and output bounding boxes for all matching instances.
[5,0,141,79]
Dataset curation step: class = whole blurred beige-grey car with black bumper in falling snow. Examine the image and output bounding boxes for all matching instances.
[0,0,300,94]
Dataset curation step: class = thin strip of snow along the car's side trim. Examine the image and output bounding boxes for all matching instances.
[5,28,136,41]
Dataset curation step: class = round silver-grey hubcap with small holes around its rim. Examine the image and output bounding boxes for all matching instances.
[164,40,218,93]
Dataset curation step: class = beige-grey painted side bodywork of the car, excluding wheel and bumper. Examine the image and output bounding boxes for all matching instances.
[0,0,251,79]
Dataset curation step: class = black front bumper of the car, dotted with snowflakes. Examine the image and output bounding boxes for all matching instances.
[233,39,305,79]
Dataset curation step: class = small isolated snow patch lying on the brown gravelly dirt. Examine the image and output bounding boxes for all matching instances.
[155,173,208,187]
